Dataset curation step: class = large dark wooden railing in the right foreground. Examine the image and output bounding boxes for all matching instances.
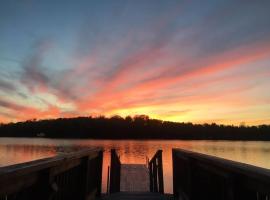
[172,149,270,200]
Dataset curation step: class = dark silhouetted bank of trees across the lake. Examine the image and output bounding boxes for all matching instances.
[0,115,270,140]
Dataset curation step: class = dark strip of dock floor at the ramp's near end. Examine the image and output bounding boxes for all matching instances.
[103,192,171,200]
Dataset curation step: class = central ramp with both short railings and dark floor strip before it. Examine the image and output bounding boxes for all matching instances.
[102,149,168,200]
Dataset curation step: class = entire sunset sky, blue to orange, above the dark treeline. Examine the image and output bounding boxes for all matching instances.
[0,0,270,125]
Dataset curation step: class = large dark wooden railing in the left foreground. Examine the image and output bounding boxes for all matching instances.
[0,149,103,200]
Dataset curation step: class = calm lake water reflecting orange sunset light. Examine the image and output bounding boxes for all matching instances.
[0,138,270,193]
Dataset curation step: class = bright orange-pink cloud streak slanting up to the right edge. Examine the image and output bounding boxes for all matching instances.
[77,38,270,115]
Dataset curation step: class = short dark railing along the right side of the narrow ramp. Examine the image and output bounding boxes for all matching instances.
[148,150,164,194]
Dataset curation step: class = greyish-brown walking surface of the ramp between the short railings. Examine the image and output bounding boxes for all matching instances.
[120,164,150,192]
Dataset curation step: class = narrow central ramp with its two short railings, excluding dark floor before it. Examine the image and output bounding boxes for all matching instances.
[107,149,164,194]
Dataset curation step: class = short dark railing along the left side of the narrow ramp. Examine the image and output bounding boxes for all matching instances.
[109,149,121,193]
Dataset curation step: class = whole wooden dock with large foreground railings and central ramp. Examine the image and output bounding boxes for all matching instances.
[0,149,270,200]
